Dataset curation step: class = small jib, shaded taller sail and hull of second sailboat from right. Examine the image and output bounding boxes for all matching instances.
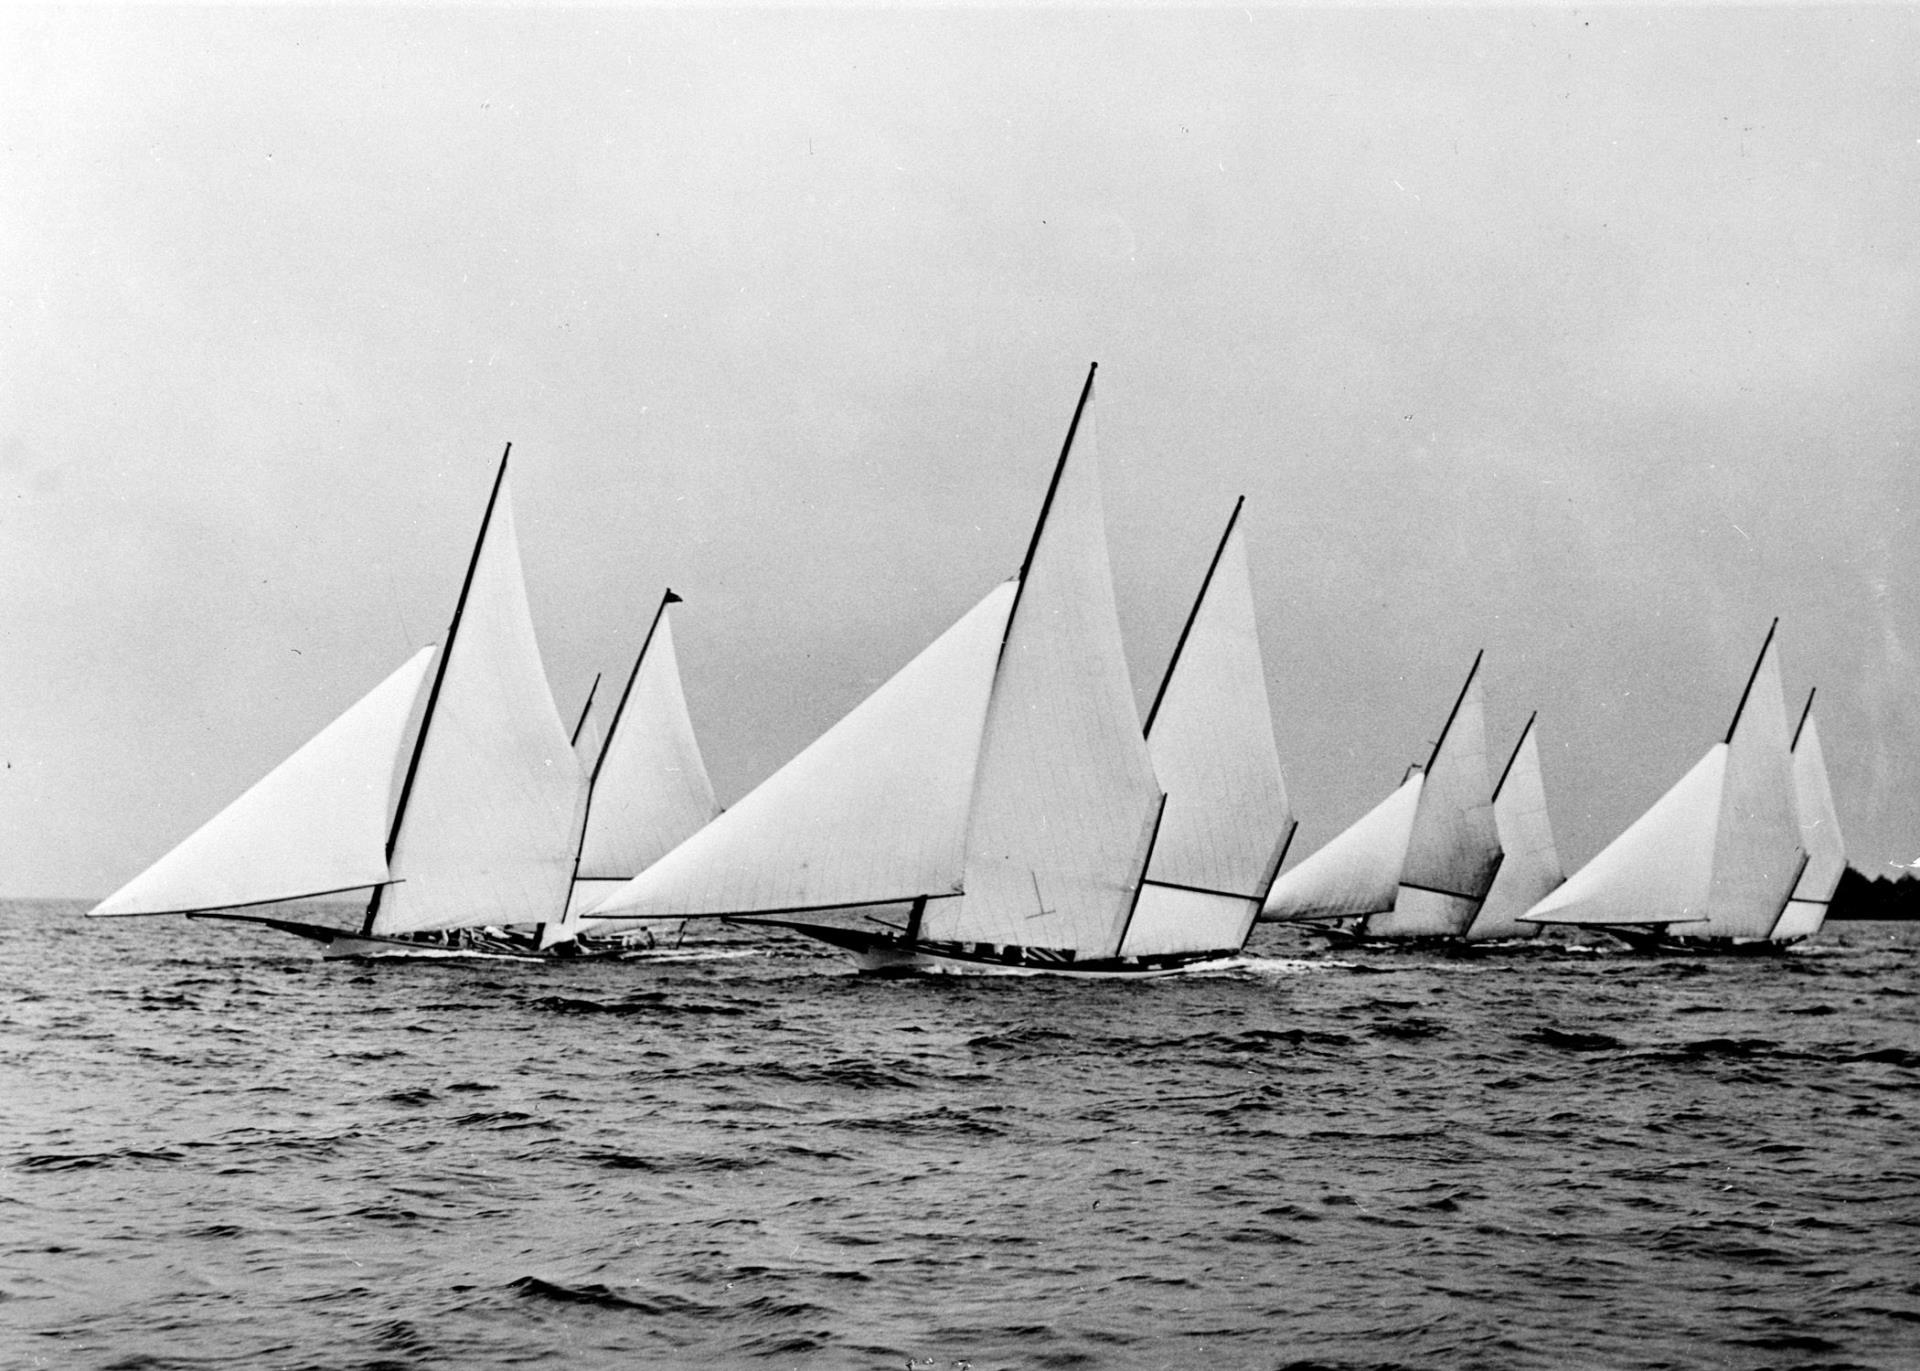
[1260,653,1501,943]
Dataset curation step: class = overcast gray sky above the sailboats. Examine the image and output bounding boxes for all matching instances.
[0,8,1920,895]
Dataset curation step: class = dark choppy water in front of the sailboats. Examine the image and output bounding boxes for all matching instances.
[0,904,1920,1371]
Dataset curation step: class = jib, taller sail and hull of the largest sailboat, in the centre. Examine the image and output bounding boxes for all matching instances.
[586,369,1246,975]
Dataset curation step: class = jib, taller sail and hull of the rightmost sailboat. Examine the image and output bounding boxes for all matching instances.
[1521,618,1804,952]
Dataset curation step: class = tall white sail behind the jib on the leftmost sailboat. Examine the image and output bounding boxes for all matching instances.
[372,476,586,935]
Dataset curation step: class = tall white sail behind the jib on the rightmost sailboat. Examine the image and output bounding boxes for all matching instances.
[1667,634,1807,939]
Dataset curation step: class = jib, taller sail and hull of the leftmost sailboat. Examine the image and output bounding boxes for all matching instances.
[90,444,586,956]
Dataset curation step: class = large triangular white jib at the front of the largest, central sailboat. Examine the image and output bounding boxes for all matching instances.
[586,582,1016,917]
